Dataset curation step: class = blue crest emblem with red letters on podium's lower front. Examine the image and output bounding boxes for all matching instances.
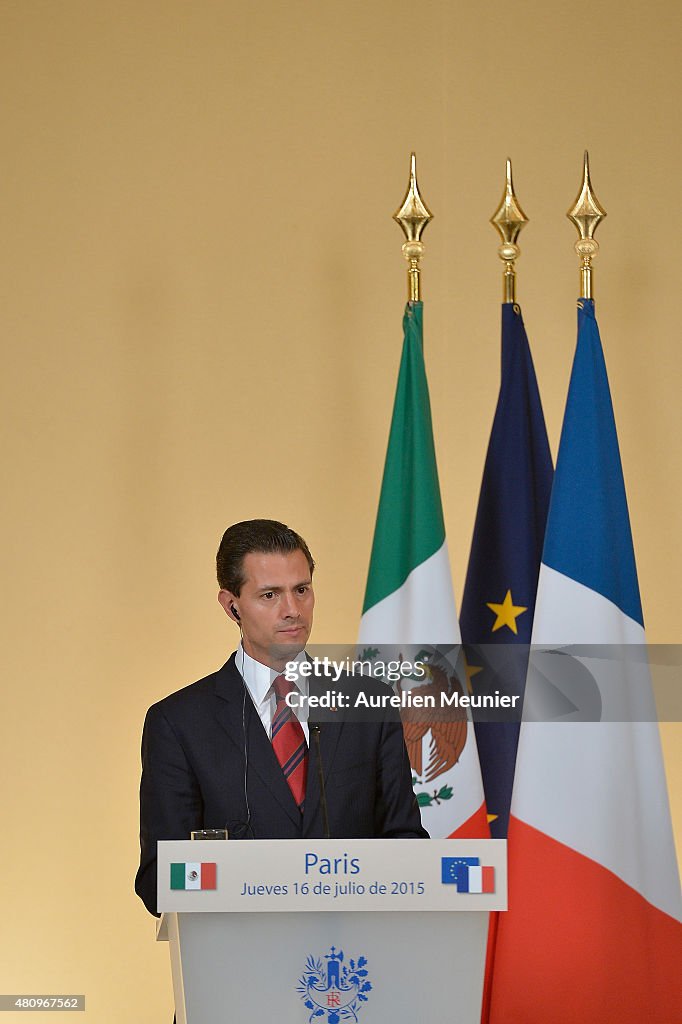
[296,946,372,1024]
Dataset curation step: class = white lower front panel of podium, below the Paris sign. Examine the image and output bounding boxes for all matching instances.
[162,911,488,1024]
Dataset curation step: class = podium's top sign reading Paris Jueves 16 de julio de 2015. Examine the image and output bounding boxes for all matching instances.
[158,839,507,913]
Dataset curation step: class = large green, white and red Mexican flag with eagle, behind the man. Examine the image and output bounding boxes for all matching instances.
[359,302,489,838]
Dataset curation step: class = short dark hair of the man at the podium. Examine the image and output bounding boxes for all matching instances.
[215,519,315,597]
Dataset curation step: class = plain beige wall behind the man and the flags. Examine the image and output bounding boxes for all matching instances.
[0,0,682,1024]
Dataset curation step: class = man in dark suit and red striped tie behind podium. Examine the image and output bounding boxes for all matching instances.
[135,519,428,913]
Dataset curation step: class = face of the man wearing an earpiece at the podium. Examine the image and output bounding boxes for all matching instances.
[218,551,315,669]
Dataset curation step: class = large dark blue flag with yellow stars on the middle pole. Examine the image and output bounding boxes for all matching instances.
[460,302,553,839]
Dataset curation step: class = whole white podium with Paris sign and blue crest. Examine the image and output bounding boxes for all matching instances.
[157,840,507,1024]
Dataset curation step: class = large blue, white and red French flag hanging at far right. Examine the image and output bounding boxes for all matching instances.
[484,299,682,1024]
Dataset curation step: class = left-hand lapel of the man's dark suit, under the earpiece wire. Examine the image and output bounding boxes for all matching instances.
[209,654,301,825]
